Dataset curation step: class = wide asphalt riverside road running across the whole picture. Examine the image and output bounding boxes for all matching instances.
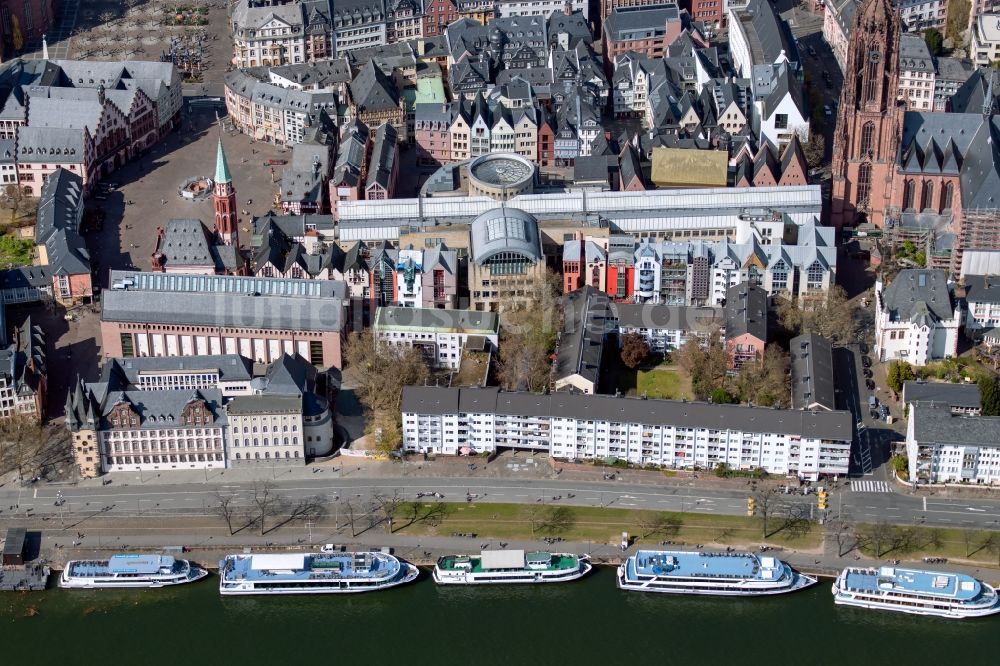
[0,472,1000,528]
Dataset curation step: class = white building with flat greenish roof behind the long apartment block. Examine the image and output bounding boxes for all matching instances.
[374,307,500,370]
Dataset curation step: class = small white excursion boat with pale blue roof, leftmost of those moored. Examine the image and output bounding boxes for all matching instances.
[59,554,208,590]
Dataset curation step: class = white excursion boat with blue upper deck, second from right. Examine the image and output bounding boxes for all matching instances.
[617,550,816,596]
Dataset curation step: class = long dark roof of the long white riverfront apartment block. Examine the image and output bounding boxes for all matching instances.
[402,386,852,441]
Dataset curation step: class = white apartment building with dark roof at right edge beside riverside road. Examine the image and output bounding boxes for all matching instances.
[906,403,1000,485]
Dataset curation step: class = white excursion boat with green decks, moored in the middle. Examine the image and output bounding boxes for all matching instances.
[434,550,593,585]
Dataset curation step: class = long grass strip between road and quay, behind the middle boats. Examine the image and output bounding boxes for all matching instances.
[386,503,822,550]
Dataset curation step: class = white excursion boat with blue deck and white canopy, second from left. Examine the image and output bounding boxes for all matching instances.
[219,551,420,595]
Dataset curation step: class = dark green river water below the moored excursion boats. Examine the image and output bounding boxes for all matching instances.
[0,568,1000,666]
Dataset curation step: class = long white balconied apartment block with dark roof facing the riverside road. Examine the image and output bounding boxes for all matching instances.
[402,386,854,480]
